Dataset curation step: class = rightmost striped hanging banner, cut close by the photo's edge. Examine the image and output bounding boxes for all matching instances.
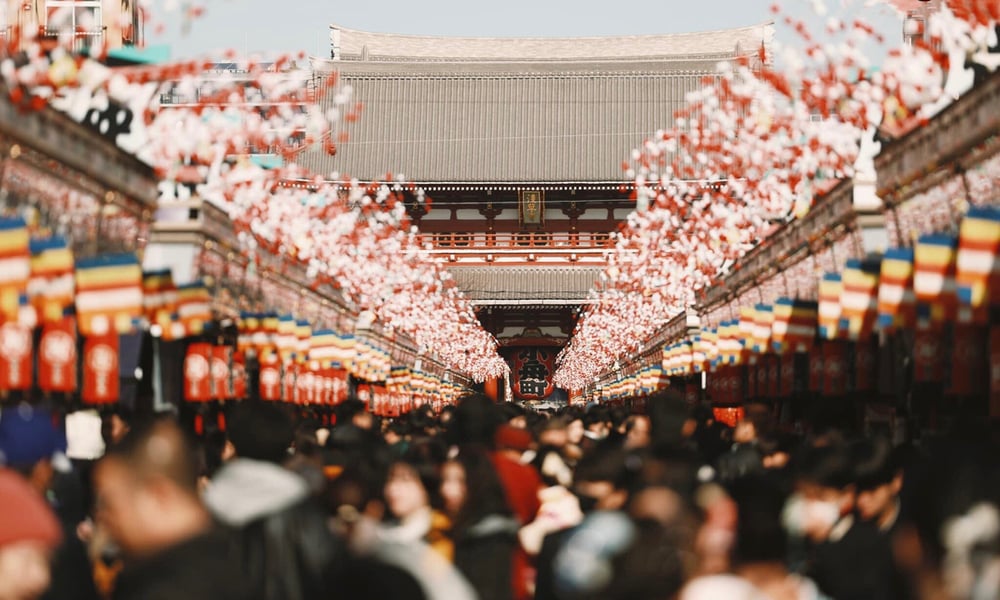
[955,207,1000,325]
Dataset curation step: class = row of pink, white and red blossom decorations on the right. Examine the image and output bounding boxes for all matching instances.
[555,0,1000,390]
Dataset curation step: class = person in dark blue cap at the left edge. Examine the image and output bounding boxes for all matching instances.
[0,404,97,600]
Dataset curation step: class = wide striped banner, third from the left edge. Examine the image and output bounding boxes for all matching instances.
[76,254,142,336]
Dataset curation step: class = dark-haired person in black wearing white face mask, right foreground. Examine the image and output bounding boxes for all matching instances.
[784,444,897,600]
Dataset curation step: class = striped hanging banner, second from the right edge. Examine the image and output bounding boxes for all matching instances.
[913,234,958,328]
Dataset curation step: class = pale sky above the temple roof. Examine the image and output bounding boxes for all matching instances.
[152,0,902,58]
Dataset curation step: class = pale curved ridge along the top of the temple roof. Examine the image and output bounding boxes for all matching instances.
[330,21,774,61]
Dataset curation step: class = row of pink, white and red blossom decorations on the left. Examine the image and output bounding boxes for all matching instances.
[0,4,508,381]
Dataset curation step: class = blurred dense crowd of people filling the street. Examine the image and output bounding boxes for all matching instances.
[0,390,1000,600]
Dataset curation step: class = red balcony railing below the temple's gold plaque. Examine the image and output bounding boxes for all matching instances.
[423,231,615,250]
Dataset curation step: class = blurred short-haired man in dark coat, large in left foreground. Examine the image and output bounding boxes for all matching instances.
[94,420,259,600]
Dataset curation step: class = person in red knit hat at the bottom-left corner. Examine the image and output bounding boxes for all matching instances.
[0,468,62,600]
